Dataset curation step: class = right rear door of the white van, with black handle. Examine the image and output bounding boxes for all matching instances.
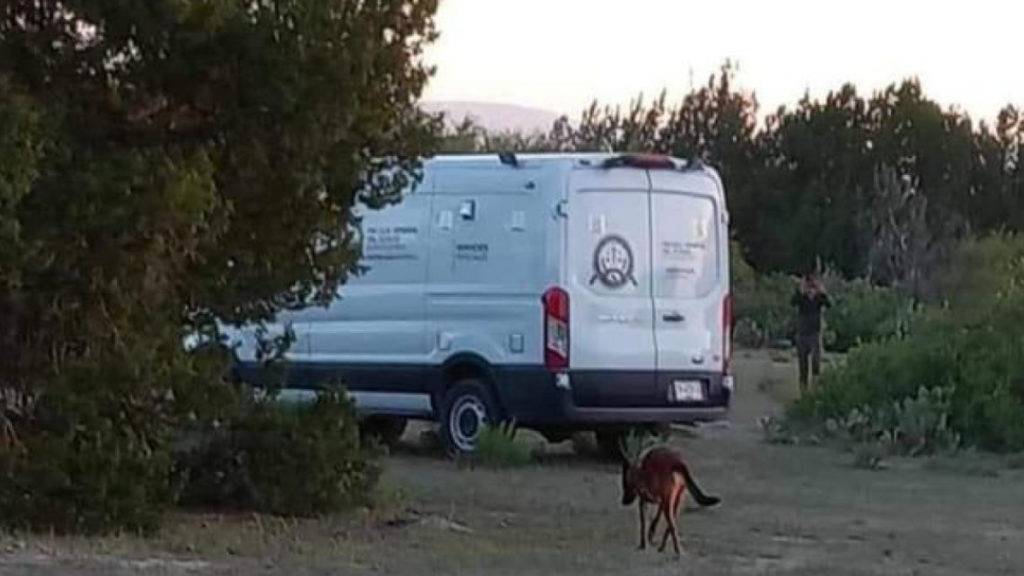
[650,170,727,379]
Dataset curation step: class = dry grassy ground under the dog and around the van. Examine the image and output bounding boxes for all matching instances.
[0,353,1024,576]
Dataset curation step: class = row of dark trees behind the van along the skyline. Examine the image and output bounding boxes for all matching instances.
[447,63,1024,280]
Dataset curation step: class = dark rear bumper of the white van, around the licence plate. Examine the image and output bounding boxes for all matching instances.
[497,369,732,427]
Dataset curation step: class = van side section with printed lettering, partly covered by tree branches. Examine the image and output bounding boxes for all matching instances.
[288,178,432,407]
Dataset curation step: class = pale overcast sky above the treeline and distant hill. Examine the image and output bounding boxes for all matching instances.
[426,0,1024,119]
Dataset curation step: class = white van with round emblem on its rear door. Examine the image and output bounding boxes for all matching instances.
[229,154,733,451]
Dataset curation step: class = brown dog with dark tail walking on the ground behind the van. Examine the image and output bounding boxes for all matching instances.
[623,447,722,556]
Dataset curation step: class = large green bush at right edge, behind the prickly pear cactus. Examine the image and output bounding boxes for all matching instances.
[790,237,1024,451]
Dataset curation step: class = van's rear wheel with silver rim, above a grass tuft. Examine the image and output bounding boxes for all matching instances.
[440,378,498,455]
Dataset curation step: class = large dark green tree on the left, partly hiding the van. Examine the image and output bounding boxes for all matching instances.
[0,0,437,525]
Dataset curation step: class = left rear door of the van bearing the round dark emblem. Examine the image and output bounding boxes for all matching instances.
[566,168,655,406]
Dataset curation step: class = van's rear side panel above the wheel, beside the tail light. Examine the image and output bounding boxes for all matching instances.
[426,165,557,367]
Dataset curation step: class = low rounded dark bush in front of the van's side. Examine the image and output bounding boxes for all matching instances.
[178,390,380,517]
